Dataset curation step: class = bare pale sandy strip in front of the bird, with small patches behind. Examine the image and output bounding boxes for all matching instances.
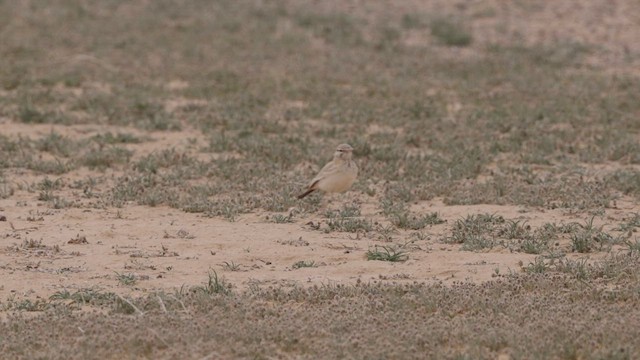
[0,124,640,299]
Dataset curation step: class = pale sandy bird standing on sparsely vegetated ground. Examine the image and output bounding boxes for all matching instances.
[298,144,358,199]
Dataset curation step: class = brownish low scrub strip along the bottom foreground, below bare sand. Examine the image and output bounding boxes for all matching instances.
[10,276,638,358]
